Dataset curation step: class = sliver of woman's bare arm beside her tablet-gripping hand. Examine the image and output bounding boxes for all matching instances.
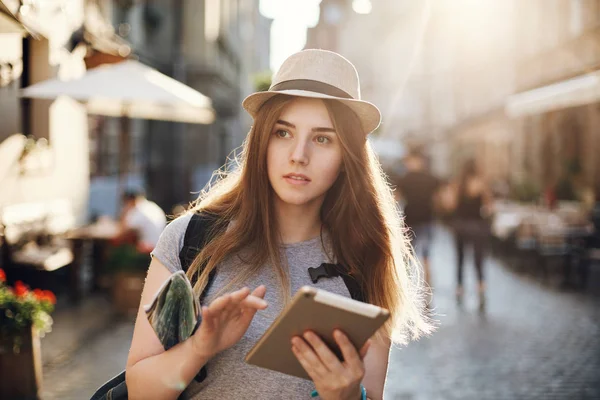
[363,335,391,400]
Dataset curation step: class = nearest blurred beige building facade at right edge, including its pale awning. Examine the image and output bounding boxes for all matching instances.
[507,0,600,196]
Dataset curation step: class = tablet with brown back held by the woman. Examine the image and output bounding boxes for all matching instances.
[245,286,390,380]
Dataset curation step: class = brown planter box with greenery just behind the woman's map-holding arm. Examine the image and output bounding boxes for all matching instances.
[112,271,146,316]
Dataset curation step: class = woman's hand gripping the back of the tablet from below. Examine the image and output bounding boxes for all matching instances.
[292,330,371,400]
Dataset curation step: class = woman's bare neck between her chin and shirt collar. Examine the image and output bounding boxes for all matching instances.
[275,201,321,244]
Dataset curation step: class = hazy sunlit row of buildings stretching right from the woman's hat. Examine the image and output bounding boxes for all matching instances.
[307,0,600,200]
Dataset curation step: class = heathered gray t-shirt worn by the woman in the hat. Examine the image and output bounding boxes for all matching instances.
[152,214,350,399]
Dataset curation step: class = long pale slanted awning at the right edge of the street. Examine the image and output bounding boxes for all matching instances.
[506,71,600,118]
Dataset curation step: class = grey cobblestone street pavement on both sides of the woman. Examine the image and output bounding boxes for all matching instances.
[43,229,600,400]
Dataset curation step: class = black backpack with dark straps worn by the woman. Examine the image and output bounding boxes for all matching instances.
[90,212,366,400]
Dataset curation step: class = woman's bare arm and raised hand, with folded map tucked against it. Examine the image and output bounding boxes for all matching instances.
[126,258,267,399]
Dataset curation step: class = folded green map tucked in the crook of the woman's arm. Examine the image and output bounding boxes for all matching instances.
[144,271,202,350]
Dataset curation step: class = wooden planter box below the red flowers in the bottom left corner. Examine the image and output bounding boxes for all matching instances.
[0,327,42,400]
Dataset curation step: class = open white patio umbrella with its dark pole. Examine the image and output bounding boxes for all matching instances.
[21,60,215,200]
